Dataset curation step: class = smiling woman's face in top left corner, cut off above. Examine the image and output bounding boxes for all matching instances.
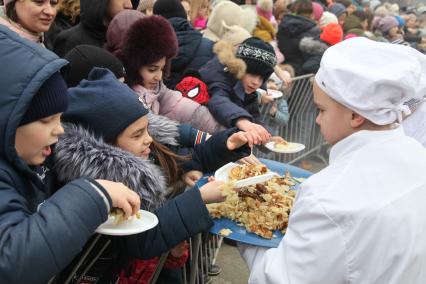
[15,0,58,33]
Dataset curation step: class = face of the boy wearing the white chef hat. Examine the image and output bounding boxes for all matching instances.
[313,81,354,145]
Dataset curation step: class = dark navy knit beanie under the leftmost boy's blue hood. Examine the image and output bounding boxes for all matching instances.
[19,72,68,126]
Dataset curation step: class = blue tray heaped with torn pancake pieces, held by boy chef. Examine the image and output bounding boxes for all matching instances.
[201,159,311,248]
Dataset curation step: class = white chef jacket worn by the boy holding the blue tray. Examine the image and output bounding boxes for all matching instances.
[240,127,426,284]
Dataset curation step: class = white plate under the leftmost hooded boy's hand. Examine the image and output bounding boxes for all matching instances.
[96,210,158,236]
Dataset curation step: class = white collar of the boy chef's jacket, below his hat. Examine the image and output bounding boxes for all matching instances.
[330,126,405,165]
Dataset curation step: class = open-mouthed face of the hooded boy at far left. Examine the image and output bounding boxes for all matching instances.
[15,113,64,166]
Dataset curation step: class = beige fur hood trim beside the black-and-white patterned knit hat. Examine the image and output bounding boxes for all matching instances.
[213,41,247,80]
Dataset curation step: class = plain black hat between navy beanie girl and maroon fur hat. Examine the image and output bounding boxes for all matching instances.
[62,44,126,88]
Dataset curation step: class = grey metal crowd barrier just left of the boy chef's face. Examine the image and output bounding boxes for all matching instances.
[253,74,327,164]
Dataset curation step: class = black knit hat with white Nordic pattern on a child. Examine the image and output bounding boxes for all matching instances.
[236,37,277,82]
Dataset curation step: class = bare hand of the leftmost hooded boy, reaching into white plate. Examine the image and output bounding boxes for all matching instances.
[96,179,141,220]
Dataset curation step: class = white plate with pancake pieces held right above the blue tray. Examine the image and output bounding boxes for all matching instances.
[214,163,278,188]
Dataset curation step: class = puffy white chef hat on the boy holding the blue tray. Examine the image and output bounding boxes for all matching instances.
[315,37,426,125]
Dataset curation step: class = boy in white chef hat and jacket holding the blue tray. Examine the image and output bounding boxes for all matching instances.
[239,38,426,284]
